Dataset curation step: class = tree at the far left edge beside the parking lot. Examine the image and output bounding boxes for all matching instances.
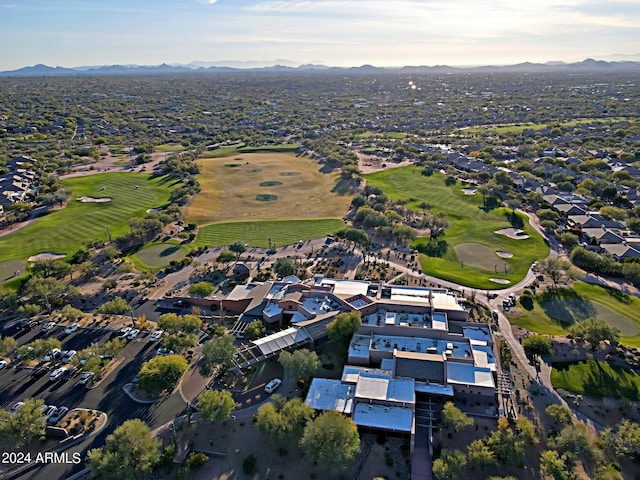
[0,398,47,447]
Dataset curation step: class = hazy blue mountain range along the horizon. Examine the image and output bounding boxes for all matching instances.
[0,58,640,77]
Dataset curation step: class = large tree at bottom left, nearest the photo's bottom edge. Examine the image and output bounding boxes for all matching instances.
[87,418,160,480]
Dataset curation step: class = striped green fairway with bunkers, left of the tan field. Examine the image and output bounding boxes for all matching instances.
[0,173,177,261]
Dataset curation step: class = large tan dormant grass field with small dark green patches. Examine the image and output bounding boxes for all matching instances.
[185,152,352,225]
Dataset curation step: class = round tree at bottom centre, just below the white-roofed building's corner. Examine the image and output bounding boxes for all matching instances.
[300,410,360,473]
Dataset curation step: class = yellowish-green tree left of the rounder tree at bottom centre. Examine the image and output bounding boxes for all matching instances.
[255,394,313,445]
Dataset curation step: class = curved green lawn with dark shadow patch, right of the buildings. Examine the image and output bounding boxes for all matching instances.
[509,282,640,346]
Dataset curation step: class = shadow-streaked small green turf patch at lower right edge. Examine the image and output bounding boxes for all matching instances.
[551,360,640,400]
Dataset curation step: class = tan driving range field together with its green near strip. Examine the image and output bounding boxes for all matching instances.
[185,151,352,247]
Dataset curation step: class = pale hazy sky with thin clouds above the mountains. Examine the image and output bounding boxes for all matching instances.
[0,0,640,70]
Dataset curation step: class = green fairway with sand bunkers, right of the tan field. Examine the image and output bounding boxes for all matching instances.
[364,166,549,289]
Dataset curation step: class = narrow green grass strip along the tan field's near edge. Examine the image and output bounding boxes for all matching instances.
[191,218,344,247]
